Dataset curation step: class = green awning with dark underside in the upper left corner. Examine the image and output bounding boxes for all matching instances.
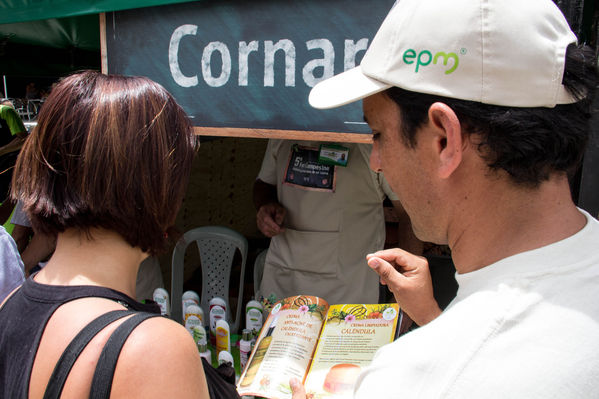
[0,0,203,77]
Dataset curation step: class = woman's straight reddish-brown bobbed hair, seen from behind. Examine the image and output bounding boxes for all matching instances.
[12,71,196,254]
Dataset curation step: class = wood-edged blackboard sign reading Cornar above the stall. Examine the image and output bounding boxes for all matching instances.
[105,0,395,141]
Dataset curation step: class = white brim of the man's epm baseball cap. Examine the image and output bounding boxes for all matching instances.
[308,66,391,109]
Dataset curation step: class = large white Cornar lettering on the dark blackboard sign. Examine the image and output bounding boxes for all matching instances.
[168,24,368,87]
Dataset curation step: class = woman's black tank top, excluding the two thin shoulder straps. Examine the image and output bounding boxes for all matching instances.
[0,277,160,399]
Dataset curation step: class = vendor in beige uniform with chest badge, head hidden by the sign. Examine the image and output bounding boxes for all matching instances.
[254,140,422,303]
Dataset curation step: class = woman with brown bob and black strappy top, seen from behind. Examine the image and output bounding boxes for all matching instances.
[0,72,208,398]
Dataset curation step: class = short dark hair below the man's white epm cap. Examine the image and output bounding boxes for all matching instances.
[385,44,598,187]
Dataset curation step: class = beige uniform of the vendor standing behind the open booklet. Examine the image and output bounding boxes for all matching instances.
[258,140,397,304]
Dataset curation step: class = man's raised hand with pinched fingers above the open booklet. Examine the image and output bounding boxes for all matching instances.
[366,248,441,326]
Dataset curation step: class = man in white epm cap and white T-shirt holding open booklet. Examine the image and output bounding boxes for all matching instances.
[291,0,599,399]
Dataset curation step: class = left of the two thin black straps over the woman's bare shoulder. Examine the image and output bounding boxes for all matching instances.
[44,310,134,399]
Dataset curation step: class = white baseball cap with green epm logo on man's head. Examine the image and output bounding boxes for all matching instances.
[308,0,577,108]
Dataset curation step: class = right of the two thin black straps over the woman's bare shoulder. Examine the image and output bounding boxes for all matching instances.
[89,313,160,399]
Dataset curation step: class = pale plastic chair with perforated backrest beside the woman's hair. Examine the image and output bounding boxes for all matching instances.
[171,226,248,333]
